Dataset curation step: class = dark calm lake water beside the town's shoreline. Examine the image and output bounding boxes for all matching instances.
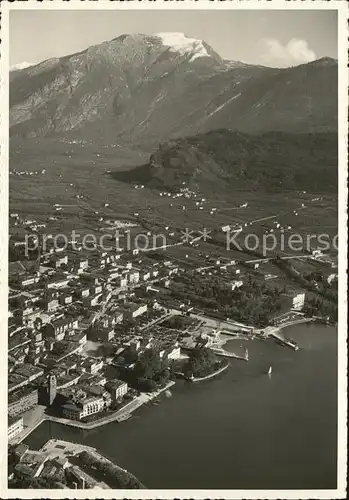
[25,324,337,489]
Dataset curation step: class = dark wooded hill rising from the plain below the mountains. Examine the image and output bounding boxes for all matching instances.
[112,129,338,192]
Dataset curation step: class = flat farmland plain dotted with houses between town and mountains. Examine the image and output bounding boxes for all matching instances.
[10,140,337,270]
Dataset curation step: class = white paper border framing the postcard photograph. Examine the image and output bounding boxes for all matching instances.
[0,0,348,499]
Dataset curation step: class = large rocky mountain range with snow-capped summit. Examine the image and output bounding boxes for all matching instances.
[10,33,337,145]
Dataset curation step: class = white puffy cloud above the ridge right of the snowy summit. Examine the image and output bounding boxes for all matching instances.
[260,38,316,67]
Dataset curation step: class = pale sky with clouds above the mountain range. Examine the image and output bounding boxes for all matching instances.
[10,9,337,67]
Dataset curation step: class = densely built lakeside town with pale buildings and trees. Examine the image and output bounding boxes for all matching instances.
[8,205,337,490]
